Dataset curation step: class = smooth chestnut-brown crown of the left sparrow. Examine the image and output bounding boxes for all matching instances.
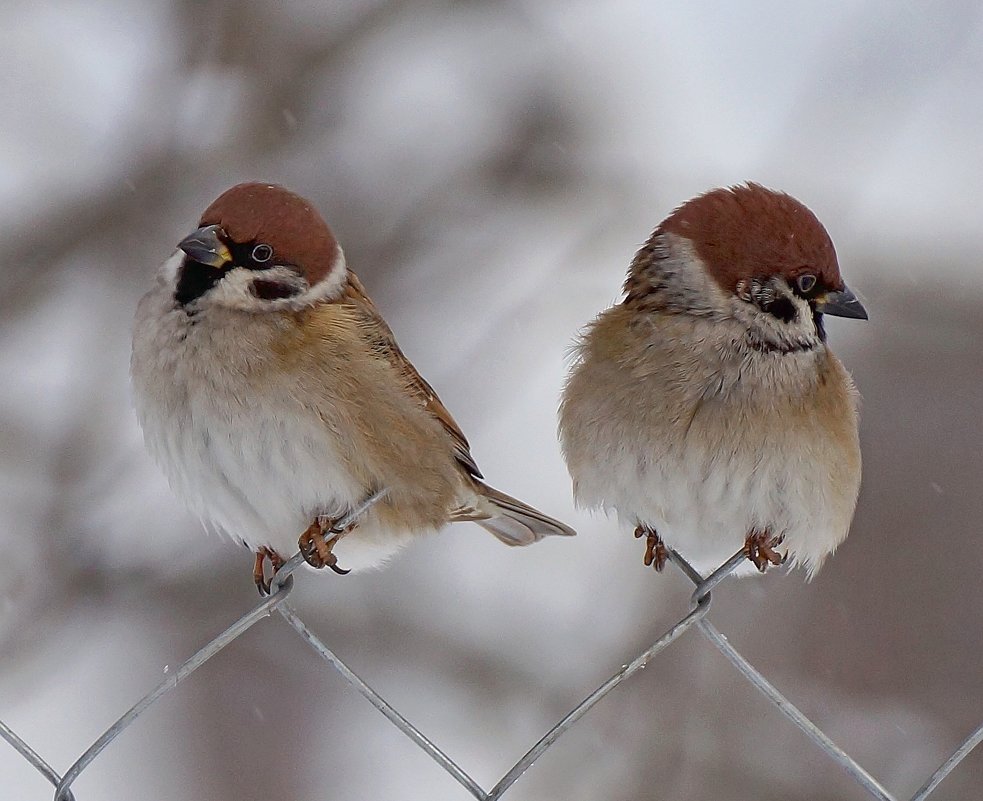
[199,182,339,286]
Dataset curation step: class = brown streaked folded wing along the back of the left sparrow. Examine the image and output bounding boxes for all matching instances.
[340,270,482,478]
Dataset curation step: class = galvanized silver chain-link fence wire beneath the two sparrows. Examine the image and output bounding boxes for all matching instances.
[0,490,983,801]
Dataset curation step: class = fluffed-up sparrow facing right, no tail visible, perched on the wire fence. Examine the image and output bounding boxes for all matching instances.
[559,183,867,578]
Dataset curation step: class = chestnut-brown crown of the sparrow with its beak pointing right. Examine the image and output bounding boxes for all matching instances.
[656,182,844,292]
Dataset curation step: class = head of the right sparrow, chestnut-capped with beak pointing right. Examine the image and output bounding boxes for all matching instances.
[625,183,867,351]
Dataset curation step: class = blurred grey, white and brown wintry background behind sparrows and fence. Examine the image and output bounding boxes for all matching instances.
[0,0,983,801]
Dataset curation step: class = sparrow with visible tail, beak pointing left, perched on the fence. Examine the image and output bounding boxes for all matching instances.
[130,183,574,593]
